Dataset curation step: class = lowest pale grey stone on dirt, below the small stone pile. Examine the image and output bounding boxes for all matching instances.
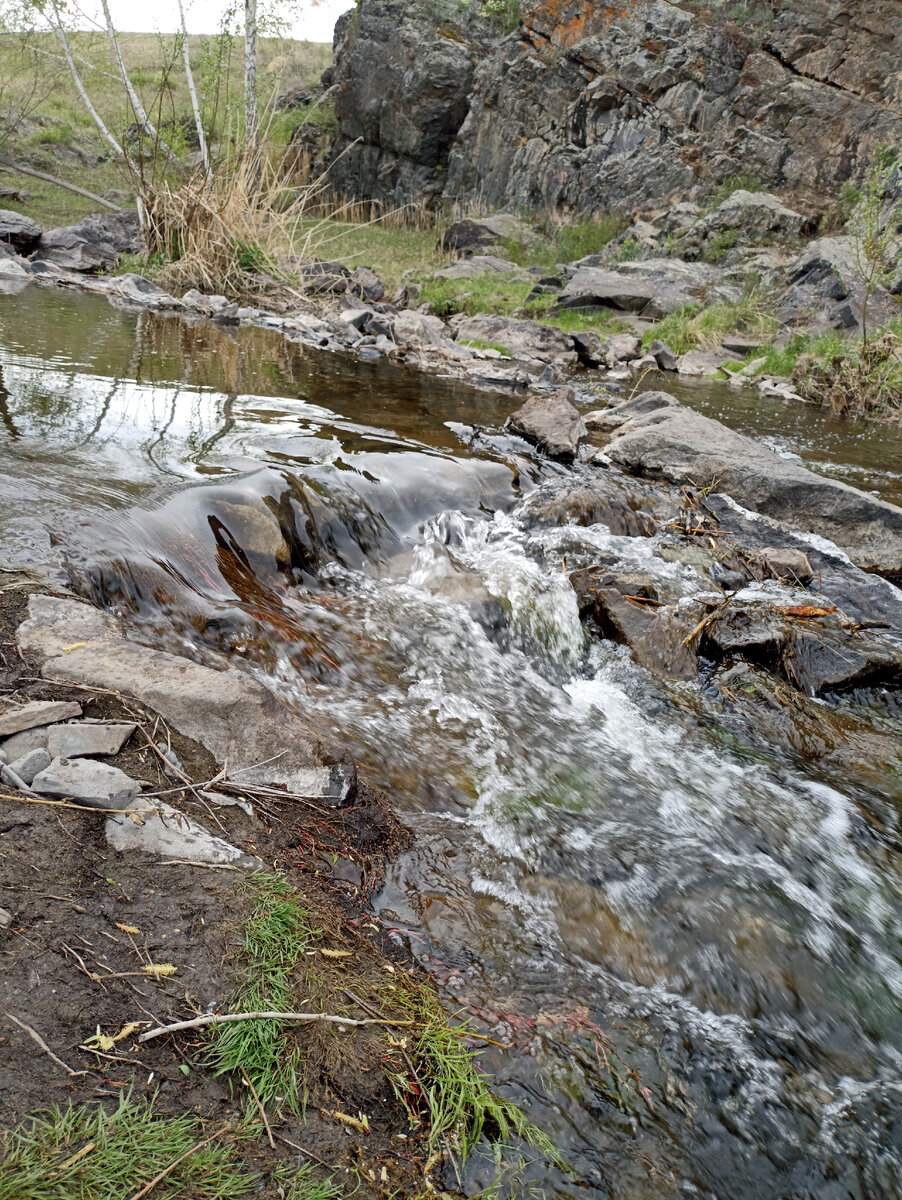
[104,799,263,870]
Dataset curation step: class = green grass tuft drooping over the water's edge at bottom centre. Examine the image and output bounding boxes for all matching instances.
[390,988,569,1170]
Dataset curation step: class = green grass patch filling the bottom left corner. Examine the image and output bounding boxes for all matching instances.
[0,1096,254,1200]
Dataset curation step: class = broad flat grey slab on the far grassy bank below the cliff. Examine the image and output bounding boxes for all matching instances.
[558,257,740,320]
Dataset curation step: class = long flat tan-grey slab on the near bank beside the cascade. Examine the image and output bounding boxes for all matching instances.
[17,595,356,804]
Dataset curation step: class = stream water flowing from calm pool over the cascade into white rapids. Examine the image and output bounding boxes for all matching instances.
[0,289,902,1200]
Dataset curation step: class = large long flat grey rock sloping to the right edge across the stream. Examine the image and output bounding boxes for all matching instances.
[607,404,902,576]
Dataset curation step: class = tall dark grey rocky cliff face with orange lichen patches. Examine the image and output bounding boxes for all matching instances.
[335,0,902,214]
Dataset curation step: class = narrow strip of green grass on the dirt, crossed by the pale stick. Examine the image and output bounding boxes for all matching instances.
[208,871,314,1112]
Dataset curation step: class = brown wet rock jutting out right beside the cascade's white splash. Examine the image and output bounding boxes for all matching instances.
[570,571,698,679]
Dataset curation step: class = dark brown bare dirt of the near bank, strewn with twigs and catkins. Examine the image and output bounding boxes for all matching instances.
[0,575,436,1198]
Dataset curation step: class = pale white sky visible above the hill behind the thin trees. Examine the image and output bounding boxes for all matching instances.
[68,0,354,42]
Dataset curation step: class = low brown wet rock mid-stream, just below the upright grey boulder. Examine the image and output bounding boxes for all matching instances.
[523,470,672,538]
